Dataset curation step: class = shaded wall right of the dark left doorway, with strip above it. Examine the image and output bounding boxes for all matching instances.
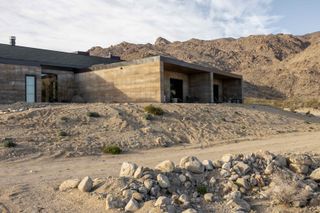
[42,69,75,102]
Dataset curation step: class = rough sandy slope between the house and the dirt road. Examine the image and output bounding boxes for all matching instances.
[0,103,320,161]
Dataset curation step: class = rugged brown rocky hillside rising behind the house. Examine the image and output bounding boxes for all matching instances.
[89,32,320,99]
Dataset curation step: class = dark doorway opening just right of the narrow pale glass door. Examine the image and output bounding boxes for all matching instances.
[41,74,58,102]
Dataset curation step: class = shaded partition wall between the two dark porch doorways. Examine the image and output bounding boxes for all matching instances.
[189,73,212,103]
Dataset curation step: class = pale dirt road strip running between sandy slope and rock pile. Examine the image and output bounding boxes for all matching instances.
[0,132,320,185]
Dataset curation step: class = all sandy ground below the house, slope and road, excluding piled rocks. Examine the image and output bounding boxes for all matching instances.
[0,103,320,212]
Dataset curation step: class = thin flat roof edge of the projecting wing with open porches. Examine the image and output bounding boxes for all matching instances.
[90,56,242,79]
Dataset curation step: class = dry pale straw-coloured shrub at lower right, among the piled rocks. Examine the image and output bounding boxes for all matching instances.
[268,174,310,206]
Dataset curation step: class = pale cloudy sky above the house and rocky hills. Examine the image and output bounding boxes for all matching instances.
[0,0,320,51]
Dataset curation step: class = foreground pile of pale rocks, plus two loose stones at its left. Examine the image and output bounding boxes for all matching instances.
[60,151,320,213]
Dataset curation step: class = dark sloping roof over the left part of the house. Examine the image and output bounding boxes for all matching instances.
[0,44,121,70]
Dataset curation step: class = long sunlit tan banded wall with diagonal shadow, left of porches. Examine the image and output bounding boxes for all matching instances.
[75,61,161,103]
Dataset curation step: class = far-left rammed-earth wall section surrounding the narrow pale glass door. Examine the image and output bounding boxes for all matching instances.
[0,64,41,104]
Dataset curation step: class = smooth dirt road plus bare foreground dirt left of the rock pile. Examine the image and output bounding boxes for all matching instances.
[0,132,320,212]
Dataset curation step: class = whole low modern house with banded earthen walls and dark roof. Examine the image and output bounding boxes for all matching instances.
[0,38,242,103]
